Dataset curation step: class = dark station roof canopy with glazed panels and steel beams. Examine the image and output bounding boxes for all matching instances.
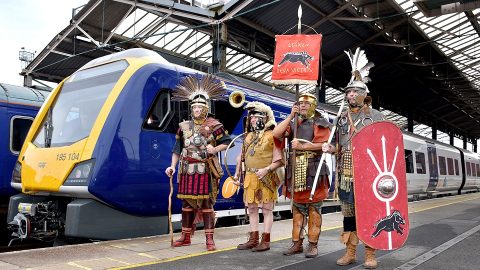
[22,0,480,139]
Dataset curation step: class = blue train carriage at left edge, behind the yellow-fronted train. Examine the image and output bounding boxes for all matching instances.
[0,83,49,201]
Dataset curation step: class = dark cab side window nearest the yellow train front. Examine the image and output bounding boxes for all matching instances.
[143,89,171,130]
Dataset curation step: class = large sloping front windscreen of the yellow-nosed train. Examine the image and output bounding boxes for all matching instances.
[33,61,128,148]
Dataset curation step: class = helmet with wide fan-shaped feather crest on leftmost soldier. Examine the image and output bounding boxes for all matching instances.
[172,74,225,119]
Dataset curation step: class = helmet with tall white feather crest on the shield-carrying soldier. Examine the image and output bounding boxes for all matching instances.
[345,48,374,107]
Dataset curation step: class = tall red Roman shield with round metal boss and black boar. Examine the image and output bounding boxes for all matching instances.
[352,121,409,250]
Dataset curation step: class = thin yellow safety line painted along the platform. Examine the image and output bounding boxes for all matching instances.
[110,195,480,270]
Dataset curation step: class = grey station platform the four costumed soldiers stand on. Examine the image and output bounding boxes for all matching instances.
[0,193,480,270]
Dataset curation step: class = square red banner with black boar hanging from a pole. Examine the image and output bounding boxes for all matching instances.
[272,34,322,84]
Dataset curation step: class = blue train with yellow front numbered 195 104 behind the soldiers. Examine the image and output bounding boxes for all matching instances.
[8,49,480,243]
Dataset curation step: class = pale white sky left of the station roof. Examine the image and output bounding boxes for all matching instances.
[0,0,88,85]
